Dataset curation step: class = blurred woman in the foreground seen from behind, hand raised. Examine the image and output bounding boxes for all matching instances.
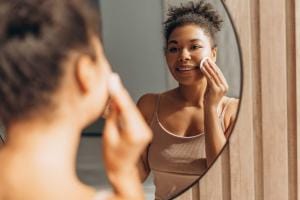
[0,0,151,200]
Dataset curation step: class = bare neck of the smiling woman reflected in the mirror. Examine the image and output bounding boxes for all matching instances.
[175,78,207,107]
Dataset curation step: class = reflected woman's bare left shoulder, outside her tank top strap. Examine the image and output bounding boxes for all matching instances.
[137,93,158,124]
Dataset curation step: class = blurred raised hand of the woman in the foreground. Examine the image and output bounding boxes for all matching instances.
[103,74,152,199]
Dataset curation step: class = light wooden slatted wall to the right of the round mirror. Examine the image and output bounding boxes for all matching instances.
[171,0,300,200]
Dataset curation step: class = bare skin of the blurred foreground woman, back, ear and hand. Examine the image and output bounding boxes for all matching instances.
[0,37,151,200]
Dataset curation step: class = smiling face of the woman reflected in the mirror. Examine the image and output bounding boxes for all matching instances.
[165,24,217,85]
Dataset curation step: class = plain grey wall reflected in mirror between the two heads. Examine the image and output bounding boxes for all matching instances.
[100,0,166,101]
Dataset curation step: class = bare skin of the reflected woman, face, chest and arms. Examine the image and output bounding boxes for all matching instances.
[137,24,238,180]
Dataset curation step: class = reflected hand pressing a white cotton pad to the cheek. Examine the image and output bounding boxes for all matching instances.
[200,58,229,107]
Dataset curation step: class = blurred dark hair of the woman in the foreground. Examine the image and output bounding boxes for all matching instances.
[0,0,100,125]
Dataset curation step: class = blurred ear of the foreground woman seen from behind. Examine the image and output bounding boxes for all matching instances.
[75,55,96,93]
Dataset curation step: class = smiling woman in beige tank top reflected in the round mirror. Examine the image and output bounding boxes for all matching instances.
[138,1,238,199]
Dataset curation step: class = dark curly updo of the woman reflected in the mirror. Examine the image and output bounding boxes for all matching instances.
[164,0,223,46]
